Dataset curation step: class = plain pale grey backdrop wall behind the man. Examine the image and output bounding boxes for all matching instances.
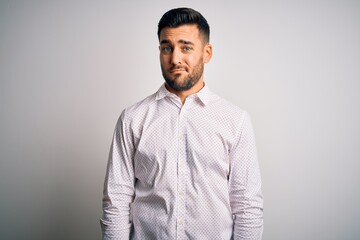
[0,0,360,240]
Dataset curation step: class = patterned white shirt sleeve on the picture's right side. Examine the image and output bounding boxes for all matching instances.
[229,112,263,240]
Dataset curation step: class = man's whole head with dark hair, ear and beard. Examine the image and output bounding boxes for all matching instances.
[158,8,212,92]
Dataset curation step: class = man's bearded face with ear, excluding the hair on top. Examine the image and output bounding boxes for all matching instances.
[159,24,212,91]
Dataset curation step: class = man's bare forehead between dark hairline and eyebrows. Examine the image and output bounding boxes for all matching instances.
[160,24,201,42]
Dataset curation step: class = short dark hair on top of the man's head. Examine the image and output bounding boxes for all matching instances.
[158,8,210,42]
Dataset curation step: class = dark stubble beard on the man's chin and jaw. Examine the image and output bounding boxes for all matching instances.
[161,59,204,92]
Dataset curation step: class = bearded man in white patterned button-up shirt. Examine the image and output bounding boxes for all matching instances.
[101,8,263,240]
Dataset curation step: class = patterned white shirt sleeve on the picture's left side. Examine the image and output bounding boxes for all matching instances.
[100,111,135,240]
